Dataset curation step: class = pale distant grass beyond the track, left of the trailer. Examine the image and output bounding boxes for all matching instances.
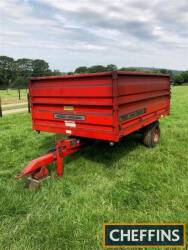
[0,89,27,104]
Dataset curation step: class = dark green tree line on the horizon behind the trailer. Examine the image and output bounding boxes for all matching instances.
[0,56,188,89]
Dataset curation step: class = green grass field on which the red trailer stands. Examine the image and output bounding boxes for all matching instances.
[0,86,188,250]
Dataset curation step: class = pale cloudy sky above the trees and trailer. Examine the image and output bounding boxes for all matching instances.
[0,0,188,72]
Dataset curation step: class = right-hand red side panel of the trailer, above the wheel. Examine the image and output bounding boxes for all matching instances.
[118,74,170,136]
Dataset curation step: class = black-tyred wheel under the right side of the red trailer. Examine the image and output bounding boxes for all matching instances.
[143,122,161,148]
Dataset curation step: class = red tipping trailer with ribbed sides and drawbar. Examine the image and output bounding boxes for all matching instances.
[17,71,170,187]
